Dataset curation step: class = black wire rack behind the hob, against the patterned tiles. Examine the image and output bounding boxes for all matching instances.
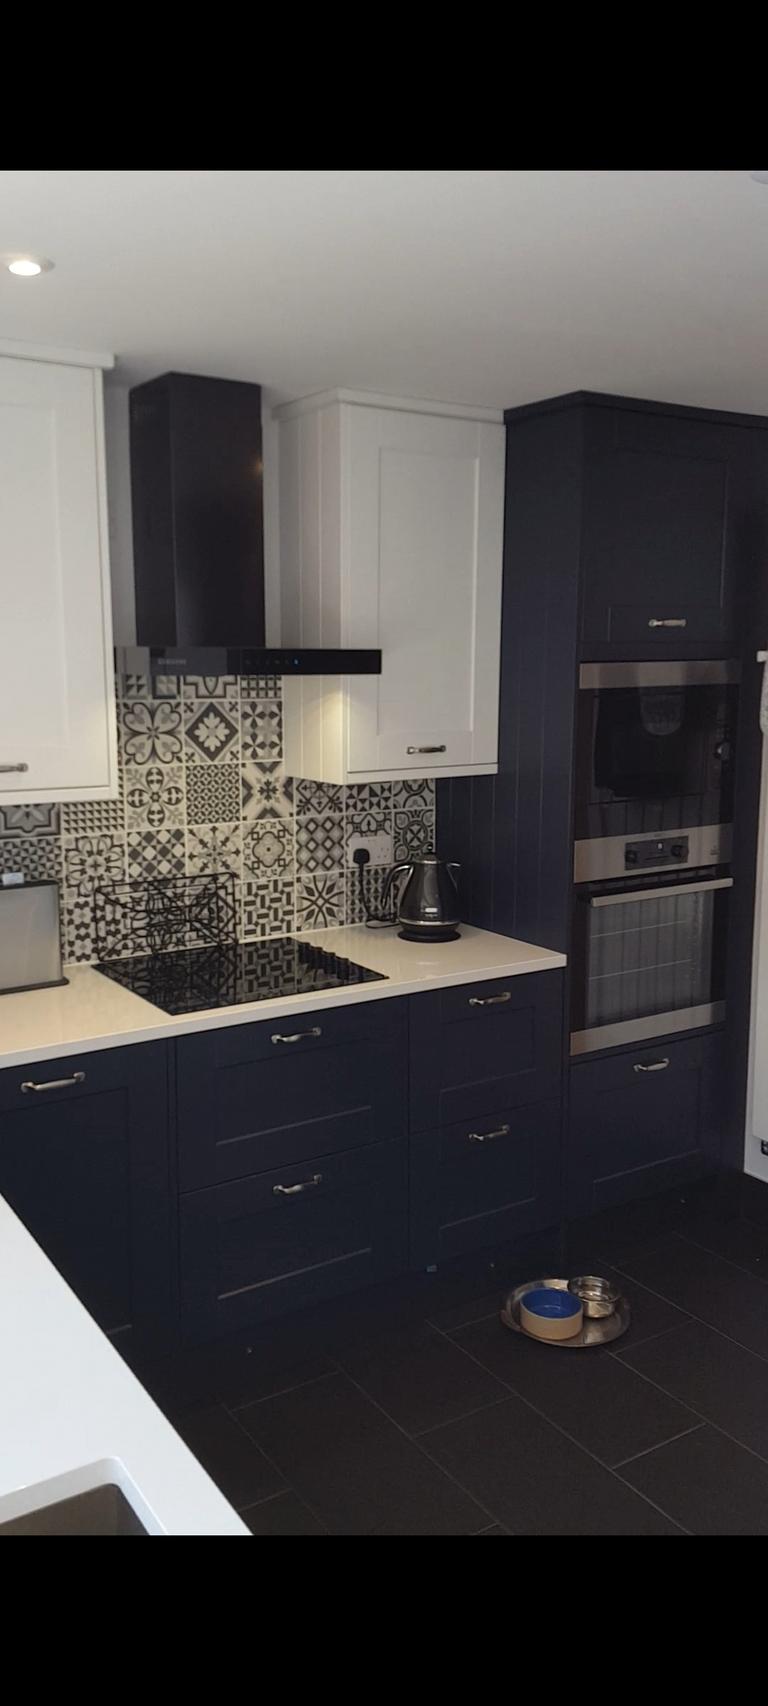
[94,872,237,960]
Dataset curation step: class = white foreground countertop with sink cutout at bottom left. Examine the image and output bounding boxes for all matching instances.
[0,1198,247,1535]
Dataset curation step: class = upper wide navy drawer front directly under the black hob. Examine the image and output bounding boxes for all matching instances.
[177,1001,408,1191]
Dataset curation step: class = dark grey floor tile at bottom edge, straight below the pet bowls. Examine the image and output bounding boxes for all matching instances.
[423,1392,679,1535]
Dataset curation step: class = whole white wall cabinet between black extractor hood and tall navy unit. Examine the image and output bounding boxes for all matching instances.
[276,391,505,783]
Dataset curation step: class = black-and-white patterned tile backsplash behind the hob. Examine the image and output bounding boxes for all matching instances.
[0,676,435,960]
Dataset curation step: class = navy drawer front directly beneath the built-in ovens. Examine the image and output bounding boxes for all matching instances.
[567,1034,725,1216]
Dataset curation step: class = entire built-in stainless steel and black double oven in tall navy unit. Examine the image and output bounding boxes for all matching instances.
[570,662,739,1054]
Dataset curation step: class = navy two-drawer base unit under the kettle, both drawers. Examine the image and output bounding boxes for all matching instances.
[410,971,563,1268]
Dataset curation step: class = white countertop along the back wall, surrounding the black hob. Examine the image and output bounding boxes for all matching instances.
[0,925,565,1070]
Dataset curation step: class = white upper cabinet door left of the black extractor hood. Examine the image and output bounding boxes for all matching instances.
[0,358,118,805]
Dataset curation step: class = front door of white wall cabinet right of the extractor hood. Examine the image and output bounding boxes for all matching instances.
[346,408,503,778]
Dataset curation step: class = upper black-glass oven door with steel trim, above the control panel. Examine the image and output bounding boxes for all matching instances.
[573,660,739,882]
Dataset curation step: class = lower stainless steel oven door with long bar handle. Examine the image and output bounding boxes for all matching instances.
[570,875,734,1054]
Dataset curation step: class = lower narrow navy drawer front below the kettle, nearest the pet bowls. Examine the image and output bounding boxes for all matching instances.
[411,1100,560,1268]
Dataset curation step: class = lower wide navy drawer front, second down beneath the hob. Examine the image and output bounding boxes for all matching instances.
[181,1141,408,1341]
